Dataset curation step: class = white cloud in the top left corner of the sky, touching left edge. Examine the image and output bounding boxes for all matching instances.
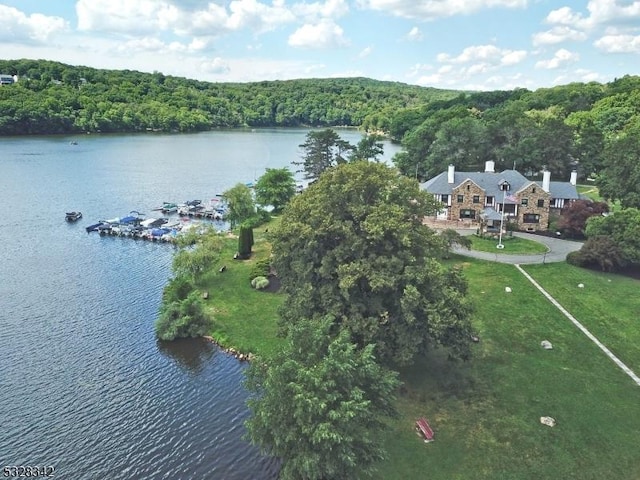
[0,5,68,43]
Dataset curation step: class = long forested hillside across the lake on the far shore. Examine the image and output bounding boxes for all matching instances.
[0,60,458,135]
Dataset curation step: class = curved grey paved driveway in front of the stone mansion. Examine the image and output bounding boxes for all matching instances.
[453,230,582,265]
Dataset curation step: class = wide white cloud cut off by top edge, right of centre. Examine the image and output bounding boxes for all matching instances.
[358,0,528,20]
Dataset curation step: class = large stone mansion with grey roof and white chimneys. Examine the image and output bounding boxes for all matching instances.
[421,161,580,231]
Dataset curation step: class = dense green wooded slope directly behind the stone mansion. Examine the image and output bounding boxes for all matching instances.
[389,76,640,205]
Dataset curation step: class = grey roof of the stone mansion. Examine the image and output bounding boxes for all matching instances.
[420,170,580,203]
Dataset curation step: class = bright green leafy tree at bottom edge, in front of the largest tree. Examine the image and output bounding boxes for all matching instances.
[247,318,398,480]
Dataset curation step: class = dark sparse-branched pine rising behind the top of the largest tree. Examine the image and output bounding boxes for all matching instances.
[293,128,353,180]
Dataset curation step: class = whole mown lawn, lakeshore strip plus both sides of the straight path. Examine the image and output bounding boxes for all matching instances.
[194,229,640,480]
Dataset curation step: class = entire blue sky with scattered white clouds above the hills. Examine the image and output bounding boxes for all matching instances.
[0,0,640,90]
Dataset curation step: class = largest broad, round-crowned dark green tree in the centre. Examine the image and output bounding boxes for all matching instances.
[272,162,471,363]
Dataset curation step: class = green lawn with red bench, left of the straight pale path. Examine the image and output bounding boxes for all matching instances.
[377,260,640,480]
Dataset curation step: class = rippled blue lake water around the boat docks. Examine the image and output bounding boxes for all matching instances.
[0,129,398,480]
